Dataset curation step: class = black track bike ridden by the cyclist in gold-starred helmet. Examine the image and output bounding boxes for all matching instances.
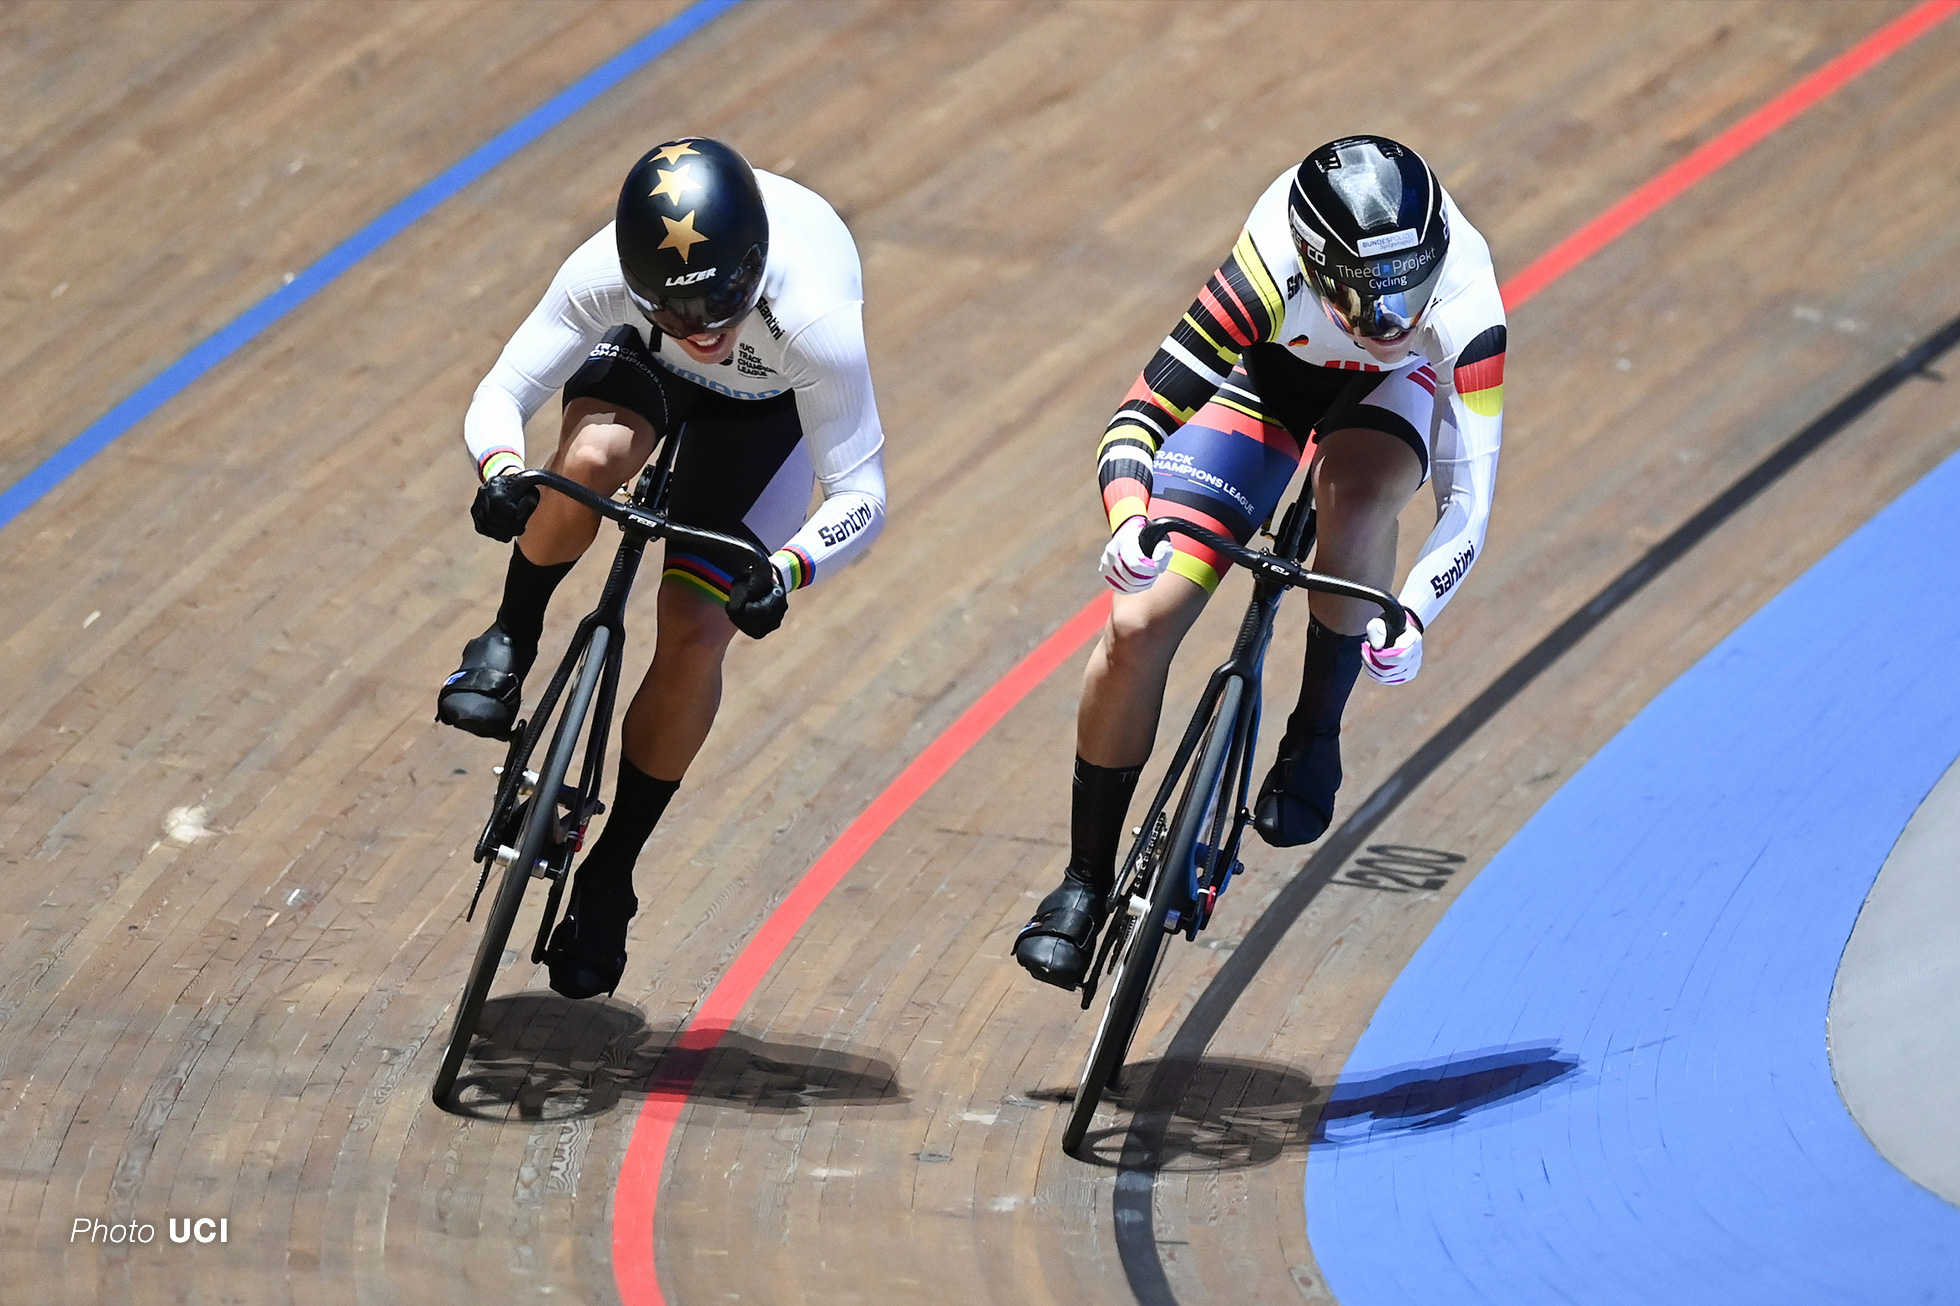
[431,435,770,1110]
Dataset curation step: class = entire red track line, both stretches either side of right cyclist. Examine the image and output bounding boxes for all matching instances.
[613,0,1960,1306]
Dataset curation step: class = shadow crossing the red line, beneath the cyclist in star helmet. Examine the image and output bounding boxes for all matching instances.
[451,992,909,1120]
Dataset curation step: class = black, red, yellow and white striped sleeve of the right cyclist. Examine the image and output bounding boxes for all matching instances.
[1096,231,1286,529]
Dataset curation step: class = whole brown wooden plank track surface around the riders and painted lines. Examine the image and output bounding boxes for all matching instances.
[0,0,1960,1306]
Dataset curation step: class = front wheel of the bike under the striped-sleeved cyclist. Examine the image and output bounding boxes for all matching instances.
[1062,677,1245,1159]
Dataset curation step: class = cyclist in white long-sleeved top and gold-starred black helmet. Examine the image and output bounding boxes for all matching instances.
[437,137,884,998]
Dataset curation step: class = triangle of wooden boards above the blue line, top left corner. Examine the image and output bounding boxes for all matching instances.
[0,0,697,494]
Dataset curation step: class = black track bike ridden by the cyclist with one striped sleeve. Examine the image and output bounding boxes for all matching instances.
[1062,494,1407,1157]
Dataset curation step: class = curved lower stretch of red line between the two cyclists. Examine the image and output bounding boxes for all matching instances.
[613,596,1109,1306]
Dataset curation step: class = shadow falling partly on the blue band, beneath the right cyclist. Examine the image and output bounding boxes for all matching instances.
[1058,1045,1578,1173]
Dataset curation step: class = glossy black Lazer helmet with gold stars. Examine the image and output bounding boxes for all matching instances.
[615,135,768,335]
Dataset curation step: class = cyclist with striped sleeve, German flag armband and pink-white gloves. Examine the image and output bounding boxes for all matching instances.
[1013,135,1505,988]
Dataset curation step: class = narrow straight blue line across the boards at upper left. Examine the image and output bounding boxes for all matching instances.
[0,0,741,527]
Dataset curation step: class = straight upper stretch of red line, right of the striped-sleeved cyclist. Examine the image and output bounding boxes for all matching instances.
[1503,0,1960,312]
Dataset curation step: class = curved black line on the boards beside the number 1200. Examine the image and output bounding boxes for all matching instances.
[1111,318,1960,1306]
